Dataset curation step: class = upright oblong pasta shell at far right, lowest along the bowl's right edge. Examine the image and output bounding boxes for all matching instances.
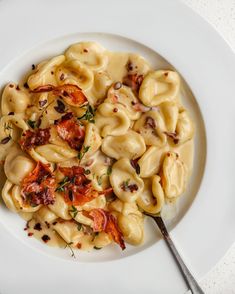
[162,152,187,198]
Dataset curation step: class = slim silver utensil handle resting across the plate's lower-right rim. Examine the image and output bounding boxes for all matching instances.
[153,216,204,294]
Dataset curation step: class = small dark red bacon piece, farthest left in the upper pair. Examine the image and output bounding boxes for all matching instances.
[19,128,50,150]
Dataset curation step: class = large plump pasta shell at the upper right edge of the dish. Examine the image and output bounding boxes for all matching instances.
[139,70,180,106]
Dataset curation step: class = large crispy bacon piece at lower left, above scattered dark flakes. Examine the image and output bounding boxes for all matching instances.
[21,161,55,206]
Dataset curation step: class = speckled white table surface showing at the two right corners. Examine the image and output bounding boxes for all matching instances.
[182,0,235,294]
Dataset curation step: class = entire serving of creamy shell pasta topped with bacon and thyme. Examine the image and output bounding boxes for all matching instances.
[0,42,194,251]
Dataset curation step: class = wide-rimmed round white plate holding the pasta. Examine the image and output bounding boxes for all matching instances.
[0,0,235,294]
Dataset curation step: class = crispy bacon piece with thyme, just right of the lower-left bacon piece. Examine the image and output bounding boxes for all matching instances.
[59,166,99,205]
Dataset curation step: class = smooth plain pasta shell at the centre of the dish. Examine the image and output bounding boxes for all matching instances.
[101,130,146,159]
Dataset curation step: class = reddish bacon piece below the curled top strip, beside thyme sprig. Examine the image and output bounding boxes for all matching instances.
[56,112,85,151]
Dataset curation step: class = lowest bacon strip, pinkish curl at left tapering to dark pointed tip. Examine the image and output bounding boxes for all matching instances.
[89,208,126,250]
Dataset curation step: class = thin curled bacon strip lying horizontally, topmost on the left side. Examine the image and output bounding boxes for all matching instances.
[31,84,87,106]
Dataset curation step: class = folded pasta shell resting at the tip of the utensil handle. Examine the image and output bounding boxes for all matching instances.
[137,175,164,214]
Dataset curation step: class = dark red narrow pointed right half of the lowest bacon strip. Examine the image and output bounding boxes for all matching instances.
[105,212,126,250]
